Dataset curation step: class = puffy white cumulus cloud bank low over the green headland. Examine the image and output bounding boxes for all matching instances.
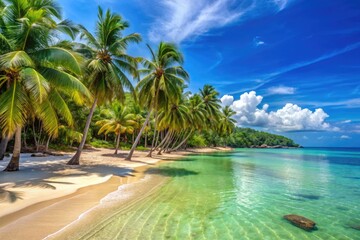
[221,91,337,131]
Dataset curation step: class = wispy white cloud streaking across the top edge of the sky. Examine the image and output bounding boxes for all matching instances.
[149,0,288,43]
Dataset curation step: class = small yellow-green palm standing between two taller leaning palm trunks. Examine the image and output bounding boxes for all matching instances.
[96,102,136,154]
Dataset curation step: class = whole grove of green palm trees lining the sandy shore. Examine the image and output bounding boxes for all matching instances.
[0,0,298,171]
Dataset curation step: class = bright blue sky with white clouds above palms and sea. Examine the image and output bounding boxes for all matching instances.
[59,0,360,147]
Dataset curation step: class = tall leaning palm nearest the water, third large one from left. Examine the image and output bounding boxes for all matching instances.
[126,42,189,160]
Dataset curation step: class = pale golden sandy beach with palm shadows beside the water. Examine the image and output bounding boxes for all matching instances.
[0,148,230,240]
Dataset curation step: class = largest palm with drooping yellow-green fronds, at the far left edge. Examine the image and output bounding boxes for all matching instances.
[0,0,89,171]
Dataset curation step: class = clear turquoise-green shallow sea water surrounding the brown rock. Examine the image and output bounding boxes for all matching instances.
[84,149,360,239]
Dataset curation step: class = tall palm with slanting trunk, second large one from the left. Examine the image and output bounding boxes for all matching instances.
[67,7,141,165]
